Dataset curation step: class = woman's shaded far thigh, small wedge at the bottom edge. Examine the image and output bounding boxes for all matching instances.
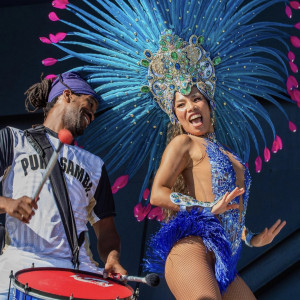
[222,276,256,300]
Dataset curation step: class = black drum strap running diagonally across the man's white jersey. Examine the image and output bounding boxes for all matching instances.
[24,126,84,269]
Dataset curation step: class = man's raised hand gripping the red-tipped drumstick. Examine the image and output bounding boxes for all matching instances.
[5,196,38,224]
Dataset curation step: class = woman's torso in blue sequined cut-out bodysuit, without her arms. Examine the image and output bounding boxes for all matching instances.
[183,139,251,260]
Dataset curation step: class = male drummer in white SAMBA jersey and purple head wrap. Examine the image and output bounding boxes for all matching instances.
[0,72,126,300]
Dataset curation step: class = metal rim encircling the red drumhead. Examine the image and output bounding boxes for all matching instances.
[12,267,134,300]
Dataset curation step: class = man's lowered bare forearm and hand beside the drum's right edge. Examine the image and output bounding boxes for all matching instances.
[93,217,127,277]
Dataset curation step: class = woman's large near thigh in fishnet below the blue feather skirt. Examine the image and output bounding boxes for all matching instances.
[165,236,222,300]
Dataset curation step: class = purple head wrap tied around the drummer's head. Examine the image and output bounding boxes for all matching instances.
[48,72,101,102]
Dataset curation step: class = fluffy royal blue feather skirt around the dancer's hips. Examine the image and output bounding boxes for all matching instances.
[144,208,237,293]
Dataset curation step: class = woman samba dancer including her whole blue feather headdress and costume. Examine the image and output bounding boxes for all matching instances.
[41,0,300,299]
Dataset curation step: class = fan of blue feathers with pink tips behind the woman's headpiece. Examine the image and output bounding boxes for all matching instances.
[40,0,300,209]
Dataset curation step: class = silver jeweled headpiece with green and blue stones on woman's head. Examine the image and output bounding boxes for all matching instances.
[141,30,221,124]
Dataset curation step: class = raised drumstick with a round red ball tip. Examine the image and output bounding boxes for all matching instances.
[32,129,73,201]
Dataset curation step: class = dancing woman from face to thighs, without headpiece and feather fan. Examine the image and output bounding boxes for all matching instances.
[147,86,285,299]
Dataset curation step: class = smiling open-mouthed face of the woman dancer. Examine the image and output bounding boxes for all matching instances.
[174,86,214,136]
